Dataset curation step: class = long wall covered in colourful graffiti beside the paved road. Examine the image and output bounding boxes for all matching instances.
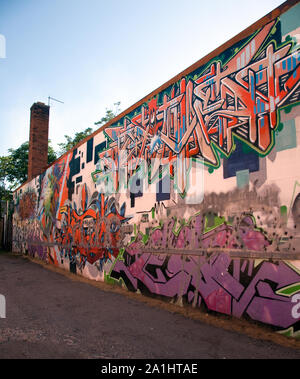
[13,1,300,337]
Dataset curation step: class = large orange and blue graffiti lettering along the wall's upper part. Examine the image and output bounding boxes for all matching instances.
[92,17,300,192]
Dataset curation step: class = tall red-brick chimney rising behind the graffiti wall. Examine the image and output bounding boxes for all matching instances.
[28,102,50,180]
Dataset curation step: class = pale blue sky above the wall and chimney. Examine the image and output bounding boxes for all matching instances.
[0,0,284,155]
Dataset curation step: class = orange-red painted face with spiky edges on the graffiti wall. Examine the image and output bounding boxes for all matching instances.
[55,185,128,268]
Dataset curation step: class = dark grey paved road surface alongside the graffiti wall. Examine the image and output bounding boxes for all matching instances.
[0,253,300,359]
